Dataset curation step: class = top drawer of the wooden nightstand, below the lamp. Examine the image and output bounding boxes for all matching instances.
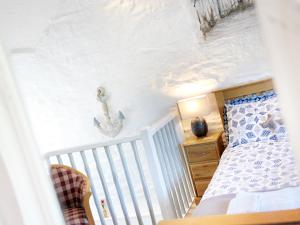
[185,143,219,163]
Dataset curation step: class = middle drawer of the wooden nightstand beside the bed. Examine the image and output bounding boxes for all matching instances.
[190,162,218,181]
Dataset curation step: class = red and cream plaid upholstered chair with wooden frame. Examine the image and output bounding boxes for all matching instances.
[51,165,95,225]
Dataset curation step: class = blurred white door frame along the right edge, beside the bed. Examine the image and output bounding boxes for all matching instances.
[257,0,300,171]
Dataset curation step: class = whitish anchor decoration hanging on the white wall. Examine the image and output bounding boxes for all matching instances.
[94,87,125,138]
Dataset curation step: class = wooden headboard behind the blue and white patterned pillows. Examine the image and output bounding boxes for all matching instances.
[213,79,274,125]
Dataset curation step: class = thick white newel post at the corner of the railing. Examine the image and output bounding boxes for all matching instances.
[141,128,177,219]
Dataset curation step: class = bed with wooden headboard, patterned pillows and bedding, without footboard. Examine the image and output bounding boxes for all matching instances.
[193,80,300,216]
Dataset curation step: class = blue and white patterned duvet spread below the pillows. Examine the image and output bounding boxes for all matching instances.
[202,138,300,200]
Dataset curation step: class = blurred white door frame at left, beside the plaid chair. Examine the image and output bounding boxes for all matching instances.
[0,44,65,225]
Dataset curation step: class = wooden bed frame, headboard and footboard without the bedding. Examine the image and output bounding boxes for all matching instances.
[159,79,300,225]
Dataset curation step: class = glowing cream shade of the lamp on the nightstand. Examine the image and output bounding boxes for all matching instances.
[177,95,211,120]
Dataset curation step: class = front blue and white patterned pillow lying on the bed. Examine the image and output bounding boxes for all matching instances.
[226,97,286,147]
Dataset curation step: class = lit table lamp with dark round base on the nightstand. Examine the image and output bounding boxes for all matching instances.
[177,95,211,137]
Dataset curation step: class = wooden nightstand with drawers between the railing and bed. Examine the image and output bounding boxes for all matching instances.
[183,132,224,197]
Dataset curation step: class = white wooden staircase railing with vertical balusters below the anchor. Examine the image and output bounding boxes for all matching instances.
[46,114,195,225]
